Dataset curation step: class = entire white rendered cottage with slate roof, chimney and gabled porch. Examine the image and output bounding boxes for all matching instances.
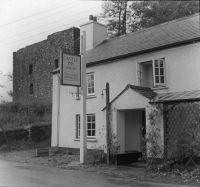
[51,14,200,159]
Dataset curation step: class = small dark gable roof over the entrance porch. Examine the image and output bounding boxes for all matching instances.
[102,84,157,110]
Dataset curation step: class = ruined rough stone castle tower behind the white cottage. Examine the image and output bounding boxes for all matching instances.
[13,27,80,104]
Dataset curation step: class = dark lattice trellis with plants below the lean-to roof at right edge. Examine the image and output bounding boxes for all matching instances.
[147,103,200,172]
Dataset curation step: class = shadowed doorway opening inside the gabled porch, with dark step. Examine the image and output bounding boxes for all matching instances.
[117,108,146,164]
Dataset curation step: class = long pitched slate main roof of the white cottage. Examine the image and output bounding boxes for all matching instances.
[86,14,200,66]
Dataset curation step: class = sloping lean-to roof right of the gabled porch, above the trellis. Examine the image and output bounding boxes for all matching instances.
[150,90,200,103]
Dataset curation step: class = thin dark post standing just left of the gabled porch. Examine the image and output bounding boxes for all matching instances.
[106,82,111,164]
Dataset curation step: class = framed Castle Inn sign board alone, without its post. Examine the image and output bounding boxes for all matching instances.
[61,53,81,87]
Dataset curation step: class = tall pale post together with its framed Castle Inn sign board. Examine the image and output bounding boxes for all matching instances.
[61,31,87,163]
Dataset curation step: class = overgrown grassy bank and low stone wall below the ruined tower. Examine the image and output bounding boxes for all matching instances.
[0,102,51,148]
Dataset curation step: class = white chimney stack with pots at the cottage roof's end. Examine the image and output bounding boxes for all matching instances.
[80,15,107,51]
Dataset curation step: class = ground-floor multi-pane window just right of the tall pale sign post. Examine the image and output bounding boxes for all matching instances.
[87,114,96,137]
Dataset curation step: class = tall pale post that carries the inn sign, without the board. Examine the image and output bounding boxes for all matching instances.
[80,31,87,164]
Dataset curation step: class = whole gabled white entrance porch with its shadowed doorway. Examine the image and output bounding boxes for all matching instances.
[108,85,155,164]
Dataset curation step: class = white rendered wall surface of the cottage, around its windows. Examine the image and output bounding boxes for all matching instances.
[52,43,200,152]
